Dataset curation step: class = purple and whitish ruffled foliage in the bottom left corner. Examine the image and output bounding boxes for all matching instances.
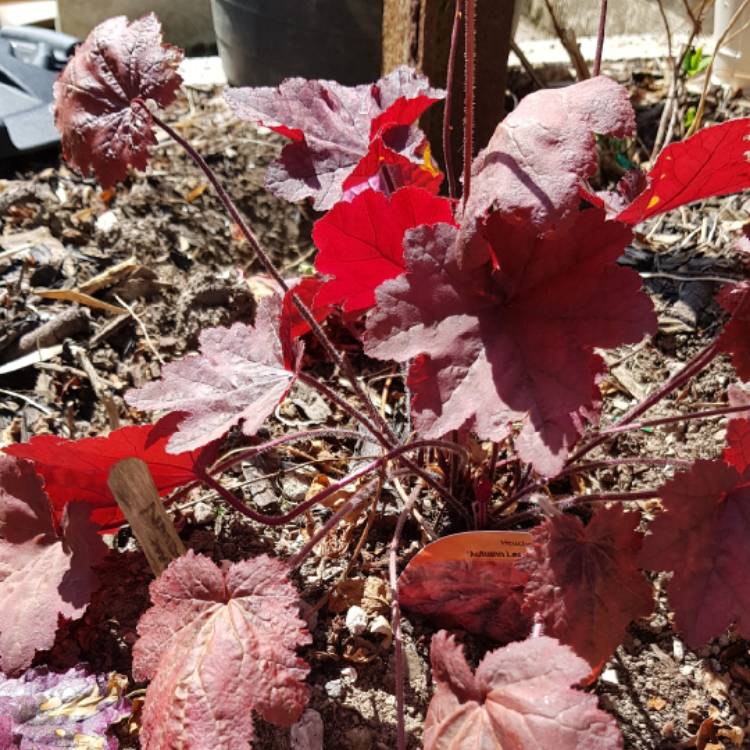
[0,667,130,750]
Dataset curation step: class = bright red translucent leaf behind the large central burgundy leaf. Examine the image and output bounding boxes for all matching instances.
[313,187,453,313]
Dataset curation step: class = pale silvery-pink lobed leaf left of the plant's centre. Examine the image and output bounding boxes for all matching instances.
[125,295,299,453]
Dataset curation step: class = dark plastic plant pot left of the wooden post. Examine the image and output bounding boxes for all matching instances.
[211,0,383,86]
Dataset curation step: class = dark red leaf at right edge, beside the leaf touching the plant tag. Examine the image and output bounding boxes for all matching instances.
[639,458,750,648]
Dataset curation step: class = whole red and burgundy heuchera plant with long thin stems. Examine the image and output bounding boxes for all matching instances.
[0,3,750,750]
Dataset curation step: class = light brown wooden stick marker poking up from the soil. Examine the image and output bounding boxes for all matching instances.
[107,458,185,577]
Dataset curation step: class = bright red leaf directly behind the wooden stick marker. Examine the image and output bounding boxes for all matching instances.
[3,415,214,529]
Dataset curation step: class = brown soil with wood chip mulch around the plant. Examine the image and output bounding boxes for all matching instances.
[0,63,750,750]
